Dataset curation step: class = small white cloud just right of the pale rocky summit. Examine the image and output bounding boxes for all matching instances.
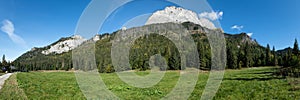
[199,11,224,21]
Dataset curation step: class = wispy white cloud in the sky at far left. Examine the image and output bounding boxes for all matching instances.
[1,20,26,46]
